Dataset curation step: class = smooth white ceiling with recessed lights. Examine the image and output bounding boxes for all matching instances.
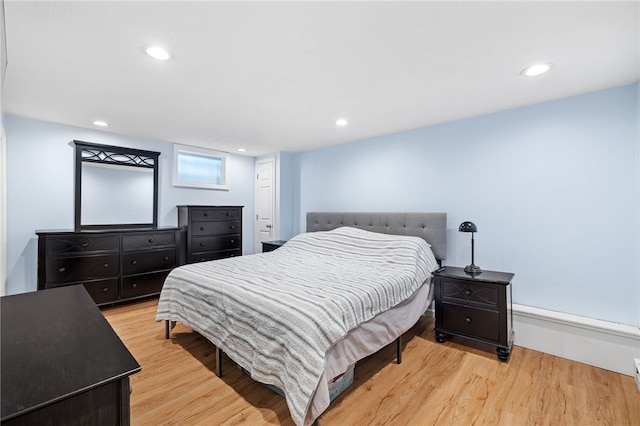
[2,0,640,156]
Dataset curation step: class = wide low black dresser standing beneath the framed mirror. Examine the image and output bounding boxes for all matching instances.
[36,227,180,305]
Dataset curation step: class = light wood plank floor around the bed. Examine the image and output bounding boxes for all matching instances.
[102,299,640,426]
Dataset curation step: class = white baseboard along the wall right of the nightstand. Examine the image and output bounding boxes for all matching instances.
[513,304,640,377]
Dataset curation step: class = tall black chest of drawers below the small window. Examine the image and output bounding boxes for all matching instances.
[178,206,242,263]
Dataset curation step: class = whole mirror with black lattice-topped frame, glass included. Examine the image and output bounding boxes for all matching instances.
[73,141,160,230]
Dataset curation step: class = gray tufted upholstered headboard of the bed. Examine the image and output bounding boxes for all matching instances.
[307,212,447,260]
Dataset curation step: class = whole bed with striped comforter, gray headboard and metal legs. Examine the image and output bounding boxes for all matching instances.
[156,212,446,426]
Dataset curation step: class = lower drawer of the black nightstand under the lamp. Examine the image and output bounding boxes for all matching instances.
[441,303,500,342]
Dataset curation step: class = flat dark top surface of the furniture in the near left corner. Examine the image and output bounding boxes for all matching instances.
[0,285,141,421]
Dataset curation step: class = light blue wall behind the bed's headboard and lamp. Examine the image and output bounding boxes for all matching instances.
[293,84,640,325]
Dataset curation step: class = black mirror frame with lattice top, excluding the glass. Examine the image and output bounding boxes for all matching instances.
[73,140,160,231]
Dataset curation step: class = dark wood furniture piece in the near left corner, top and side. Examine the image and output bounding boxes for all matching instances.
[0,285,140,426]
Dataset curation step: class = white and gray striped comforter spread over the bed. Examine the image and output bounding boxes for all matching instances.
[156,227,438,425]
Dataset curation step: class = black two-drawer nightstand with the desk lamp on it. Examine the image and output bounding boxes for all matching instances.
[433,266,514,361]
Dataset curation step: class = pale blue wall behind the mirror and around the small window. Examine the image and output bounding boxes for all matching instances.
[3,115,255,294]
